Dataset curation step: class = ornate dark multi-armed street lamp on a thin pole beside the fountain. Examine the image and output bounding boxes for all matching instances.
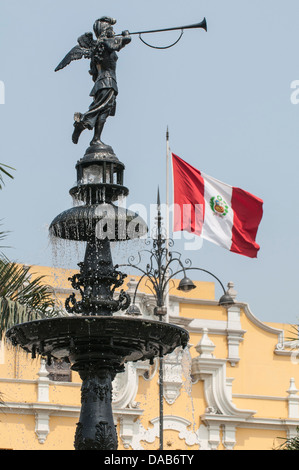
[116,189,234,450]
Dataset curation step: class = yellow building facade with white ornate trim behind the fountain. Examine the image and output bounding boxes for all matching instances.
[0,266,299,451]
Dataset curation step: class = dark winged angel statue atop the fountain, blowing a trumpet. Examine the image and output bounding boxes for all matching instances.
[55,16,131,147]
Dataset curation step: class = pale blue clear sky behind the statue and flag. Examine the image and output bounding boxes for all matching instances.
[0,0,299,322]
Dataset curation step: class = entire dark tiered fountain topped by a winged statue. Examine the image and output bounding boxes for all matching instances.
[7,17,189,450]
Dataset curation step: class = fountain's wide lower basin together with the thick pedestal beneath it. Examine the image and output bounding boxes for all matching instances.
[7,316,189,450]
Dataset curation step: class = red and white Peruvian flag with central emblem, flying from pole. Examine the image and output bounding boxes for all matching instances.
[172,154,263,258]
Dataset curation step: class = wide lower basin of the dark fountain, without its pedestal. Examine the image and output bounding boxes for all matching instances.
[6,316,189,370]
